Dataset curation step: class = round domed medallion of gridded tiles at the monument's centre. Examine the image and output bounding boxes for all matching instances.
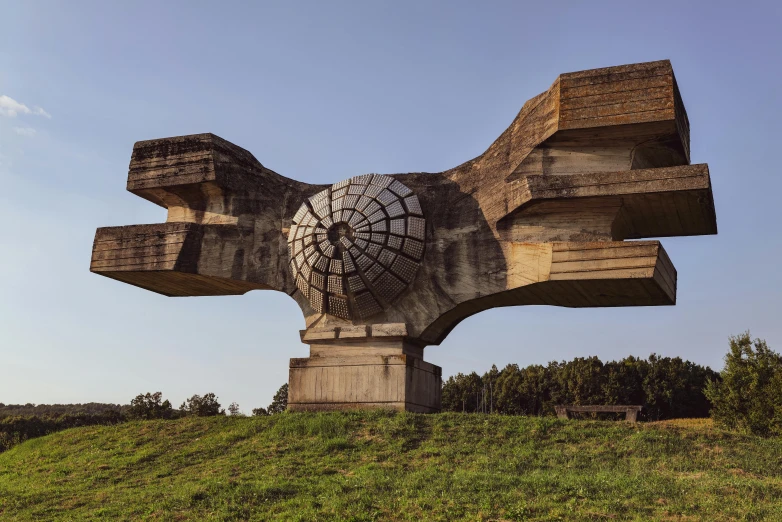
[288,174,426,319]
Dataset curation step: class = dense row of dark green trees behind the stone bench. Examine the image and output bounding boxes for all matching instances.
[442,354,720,420]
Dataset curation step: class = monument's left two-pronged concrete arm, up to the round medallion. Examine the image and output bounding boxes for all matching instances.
[91,134,324,296]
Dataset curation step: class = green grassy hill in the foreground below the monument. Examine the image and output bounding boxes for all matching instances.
[0,412,782,521]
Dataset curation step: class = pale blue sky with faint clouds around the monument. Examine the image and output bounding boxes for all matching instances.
[0,0,782,413]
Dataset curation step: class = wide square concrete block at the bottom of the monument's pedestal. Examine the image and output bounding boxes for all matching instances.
[288,350,442,413]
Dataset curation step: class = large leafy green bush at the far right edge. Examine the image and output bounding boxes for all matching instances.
[706,332,782,436]
